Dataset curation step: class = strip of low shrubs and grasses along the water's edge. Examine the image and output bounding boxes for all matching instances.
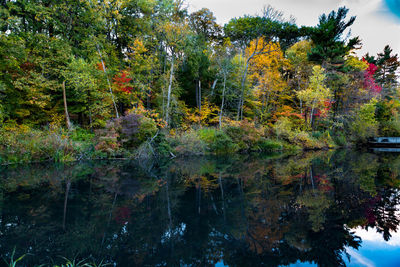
[0,121,343,165]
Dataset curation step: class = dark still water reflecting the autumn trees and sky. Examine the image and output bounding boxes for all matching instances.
[0,151,400,266]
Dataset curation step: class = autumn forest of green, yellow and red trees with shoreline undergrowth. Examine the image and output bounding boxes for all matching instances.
[0,0,400,164]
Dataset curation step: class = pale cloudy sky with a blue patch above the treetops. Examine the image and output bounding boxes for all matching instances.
[186,0,400,56]
